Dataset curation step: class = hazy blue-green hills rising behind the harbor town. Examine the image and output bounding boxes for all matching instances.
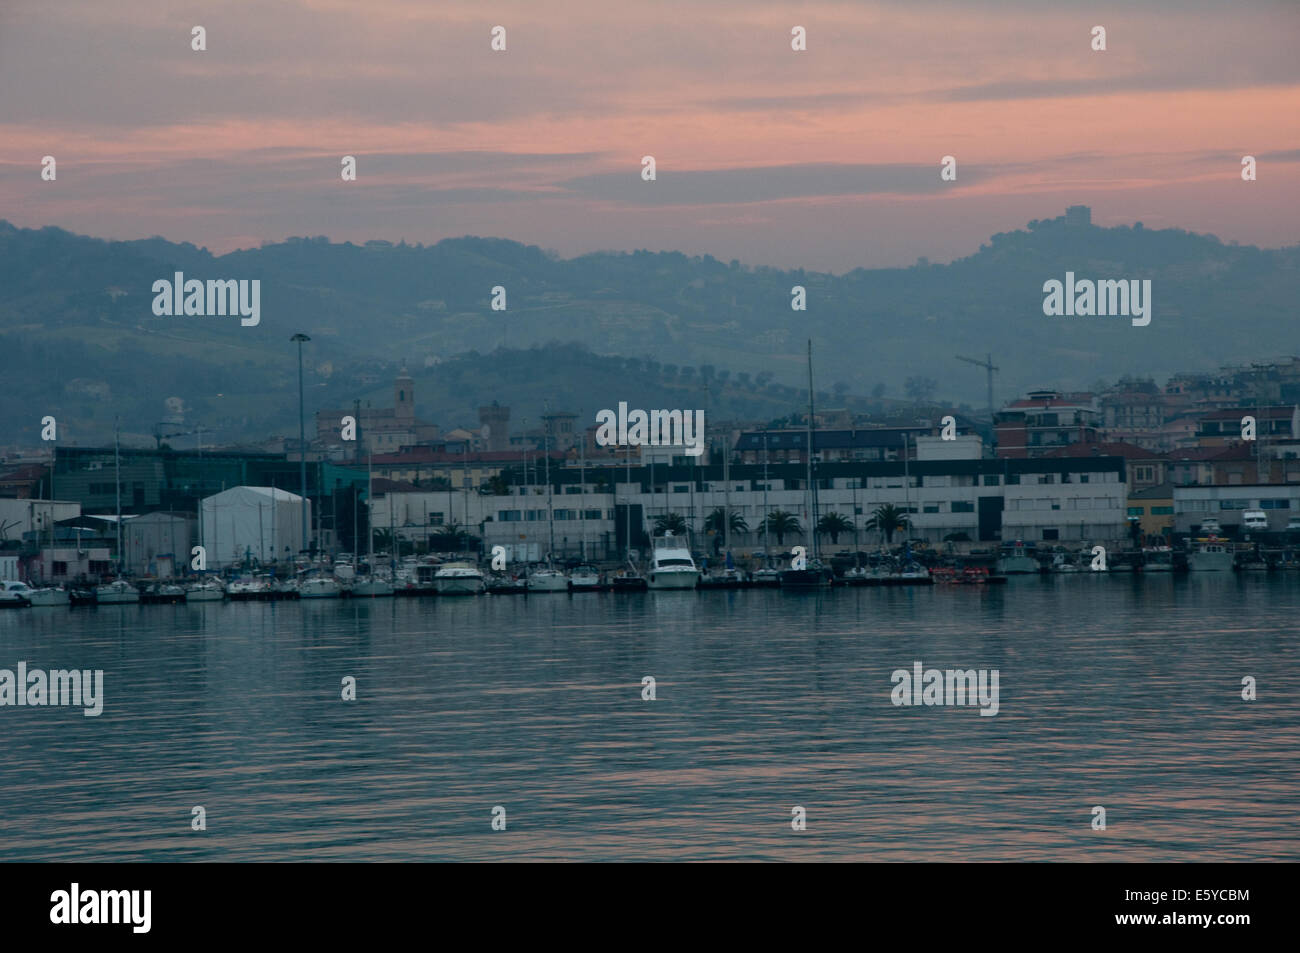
[0,218,1300,441]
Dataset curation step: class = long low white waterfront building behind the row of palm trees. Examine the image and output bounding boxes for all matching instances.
[373,456,1128,558]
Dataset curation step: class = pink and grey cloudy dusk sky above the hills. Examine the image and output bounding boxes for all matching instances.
[0,0,1300,273]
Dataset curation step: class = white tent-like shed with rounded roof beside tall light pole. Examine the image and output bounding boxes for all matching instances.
[199,486,311,569]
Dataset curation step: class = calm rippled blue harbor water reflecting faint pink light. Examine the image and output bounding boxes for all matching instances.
[0,572,1300,861]
